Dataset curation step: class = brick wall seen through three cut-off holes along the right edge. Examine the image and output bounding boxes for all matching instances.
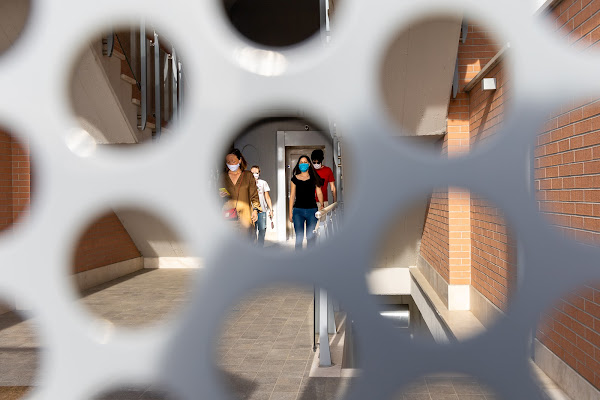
[534,0,600,389]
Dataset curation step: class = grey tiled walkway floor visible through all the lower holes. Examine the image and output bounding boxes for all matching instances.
[0,269,564,400]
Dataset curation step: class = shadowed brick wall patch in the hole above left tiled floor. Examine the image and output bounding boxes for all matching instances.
[74,212,141,273]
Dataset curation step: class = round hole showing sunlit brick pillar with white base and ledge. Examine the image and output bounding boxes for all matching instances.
[367,187,519,344]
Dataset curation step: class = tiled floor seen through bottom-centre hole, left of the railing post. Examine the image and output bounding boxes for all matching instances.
[216,286,350,400]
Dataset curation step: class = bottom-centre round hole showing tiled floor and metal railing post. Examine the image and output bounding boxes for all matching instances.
[215,285,357,400]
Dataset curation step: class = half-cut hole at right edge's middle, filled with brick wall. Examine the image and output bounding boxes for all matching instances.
[533,97,600,247]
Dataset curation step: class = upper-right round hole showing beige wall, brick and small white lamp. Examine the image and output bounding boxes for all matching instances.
[380,15,511,157]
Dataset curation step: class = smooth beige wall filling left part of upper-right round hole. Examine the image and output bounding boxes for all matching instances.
[381,14,462,136]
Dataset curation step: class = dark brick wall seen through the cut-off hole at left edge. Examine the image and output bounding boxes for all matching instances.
[0,130,31,231]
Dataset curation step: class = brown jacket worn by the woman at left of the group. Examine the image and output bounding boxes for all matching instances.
[221,171,262,228]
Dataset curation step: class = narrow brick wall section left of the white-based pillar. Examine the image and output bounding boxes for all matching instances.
[420,191,450,282]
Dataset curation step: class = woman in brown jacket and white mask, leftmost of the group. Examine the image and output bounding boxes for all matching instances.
[221,149,262,235]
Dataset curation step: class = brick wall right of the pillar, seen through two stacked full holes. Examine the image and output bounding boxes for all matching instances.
[458,23,516,309]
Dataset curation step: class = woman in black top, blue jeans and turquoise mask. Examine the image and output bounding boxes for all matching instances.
[290,155,323,250]
